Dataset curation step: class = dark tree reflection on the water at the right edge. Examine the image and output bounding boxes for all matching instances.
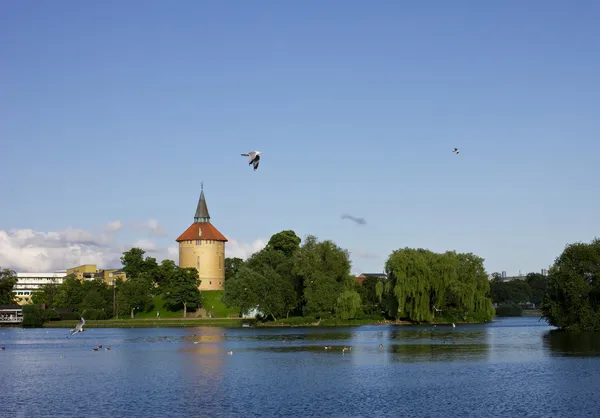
[542,330,600,357]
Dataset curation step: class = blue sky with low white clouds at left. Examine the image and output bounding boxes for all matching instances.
[0,0,600,276]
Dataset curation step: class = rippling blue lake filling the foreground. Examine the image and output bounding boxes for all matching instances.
[0,317,600,418]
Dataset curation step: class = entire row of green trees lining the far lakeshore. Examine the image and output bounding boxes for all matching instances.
[0,230,600,331]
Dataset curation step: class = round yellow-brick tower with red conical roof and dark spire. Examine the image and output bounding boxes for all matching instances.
[176,186,227,290]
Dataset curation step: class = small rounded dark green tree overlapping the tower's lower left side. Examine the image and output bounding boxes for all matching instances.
[163,267,202,318]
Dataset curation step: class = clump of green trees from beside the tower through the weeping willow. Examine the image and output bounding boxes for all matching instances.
[223,230,494,321]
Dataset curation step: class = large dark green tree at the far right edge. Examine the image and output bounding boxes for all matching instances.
[540,238,600,332]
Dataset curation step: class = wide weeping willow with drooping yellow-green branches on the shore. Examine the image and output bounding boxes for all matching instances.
[383,248,494,321]
